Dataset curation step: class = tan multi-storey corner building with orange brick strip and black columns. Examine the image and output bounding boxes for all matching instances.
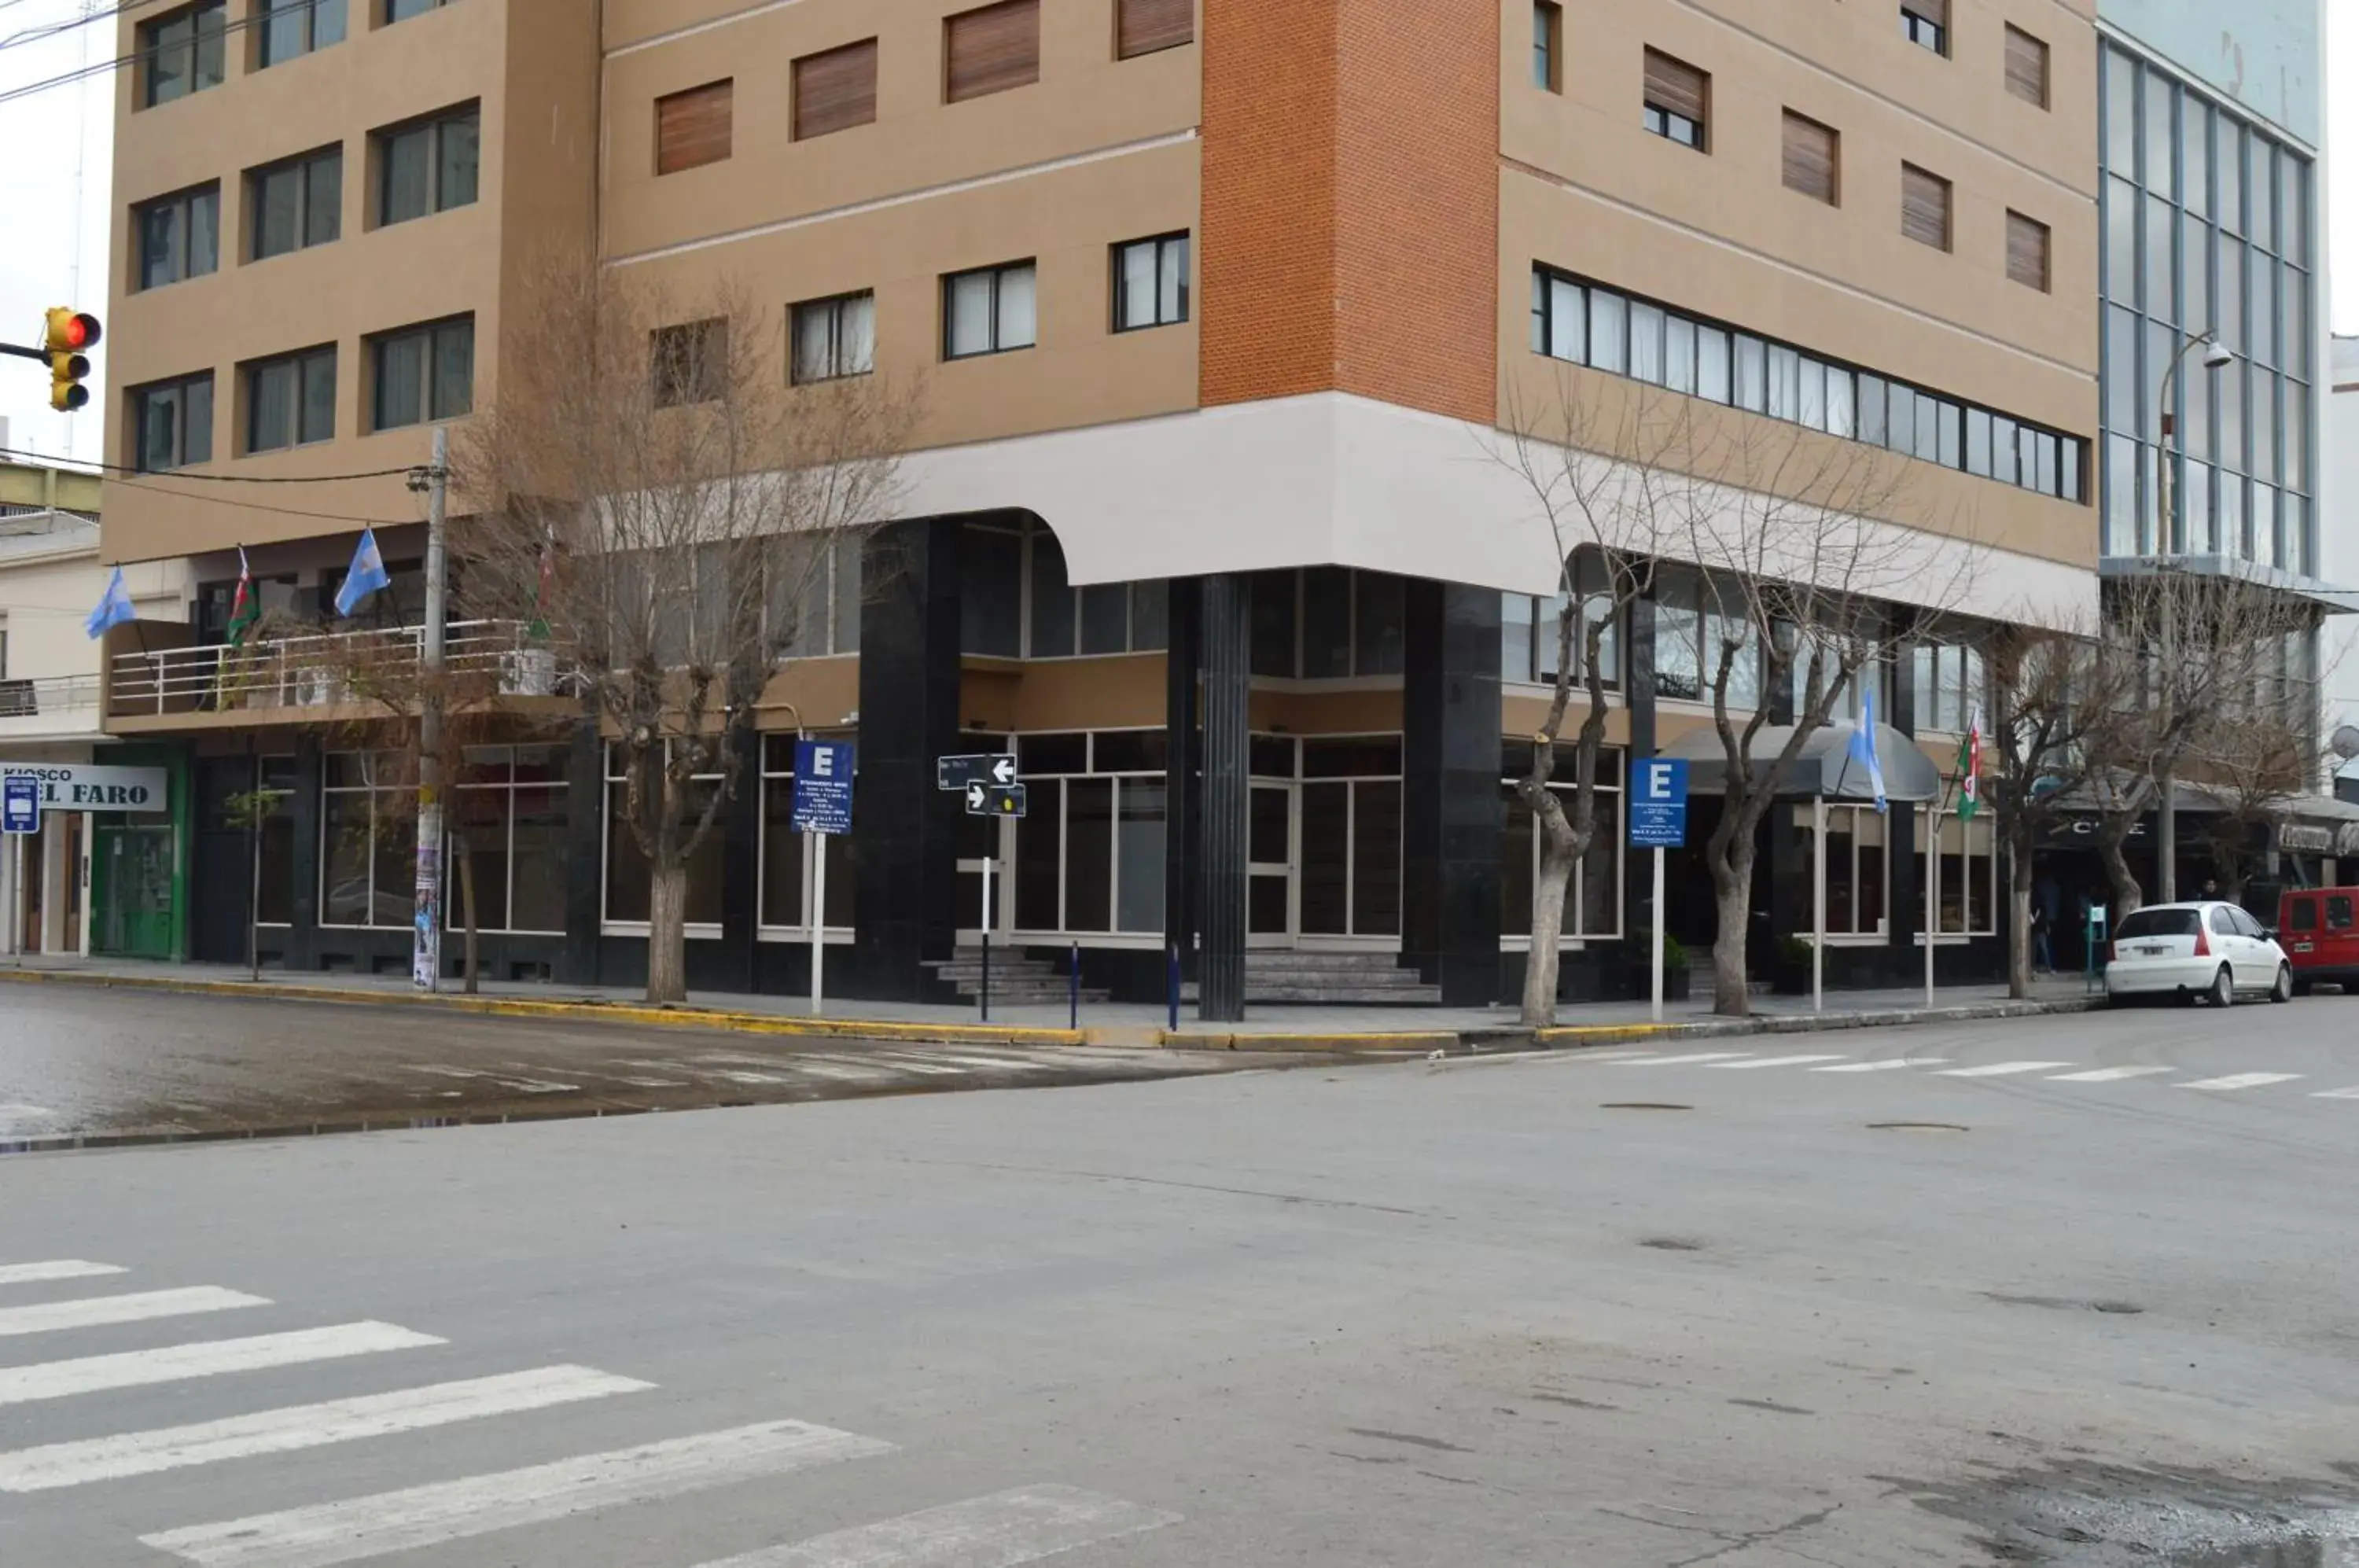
[104,0,2100,1014]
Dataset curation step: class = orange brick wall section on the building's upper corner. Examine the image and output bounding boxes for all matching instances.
[1198,0,1500,420]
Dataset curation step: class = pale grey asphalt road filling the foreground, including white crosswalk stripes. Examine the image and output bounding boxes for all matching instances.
[0,997,2359,1568]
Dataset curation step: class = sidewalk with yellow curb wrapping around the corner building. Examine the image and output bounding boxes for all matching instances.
[0,955,2095,1054]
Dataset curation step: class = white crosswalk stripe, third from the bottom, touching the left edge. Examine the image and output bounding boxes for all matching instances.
[0,1367,656,1493]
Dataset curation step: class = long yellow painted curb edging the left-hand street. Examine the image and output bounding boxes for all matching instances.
[0,969,1092,1044]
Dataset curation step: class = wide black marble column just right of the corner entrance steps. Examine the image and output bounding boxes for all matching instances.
[1401,578,1507,1007]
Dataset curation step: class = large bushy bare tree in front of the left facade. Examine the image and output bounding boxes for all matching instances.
[451,251,918,1002]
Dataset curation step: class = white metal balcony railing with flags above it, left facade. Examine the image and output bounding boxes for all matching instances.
[106,620,557,717]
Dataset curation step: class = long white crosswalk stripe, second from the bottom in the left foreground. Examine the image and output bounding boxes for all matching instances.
[139,1422,894,1568]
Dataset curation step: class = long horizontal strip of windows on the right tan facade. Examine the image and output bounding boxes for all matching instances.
[1531,267,2088,502]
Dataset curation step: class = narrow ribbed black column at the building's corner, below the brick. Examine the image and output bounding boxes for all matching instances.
[1196,573,1253,1023]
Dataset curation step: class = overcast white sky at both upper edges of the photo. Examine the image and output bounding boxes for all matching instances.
[0,0,2359,460]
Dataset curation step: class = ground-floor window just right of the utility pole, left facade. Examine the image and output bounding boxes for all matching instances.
[443,745,566,936]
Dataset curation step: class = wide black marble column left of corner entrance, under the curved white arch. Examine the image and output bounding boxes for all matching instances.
[852,517,962,1002]
